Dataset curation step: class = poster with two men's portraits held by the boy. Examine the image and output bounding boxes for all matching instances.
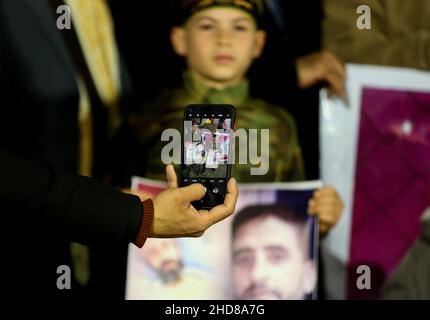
[126,177,321,300]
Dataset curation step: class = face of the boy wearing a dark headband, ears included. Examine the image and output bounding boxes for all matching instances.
[172,8,265,88]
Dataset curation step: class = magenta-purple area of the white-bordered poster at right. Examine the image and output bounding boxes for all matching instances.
[347,87,430,299]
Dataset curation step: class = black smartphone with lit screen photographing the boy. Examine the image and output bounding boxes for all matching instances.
[179,104,236,210]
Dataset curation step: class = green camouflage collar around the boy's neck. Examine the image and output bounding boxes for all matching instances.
[183,71,249,106]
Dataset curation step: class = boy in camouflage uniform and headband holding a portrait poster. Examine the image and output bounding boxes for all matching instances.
[127,0,343,232]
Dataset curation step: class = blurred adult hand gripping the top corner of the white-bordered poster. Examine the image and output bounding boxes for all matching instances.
[296,50,345,97]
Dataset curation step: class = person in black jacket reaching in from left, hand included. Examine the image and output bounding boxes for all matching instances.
[0,149,237,299]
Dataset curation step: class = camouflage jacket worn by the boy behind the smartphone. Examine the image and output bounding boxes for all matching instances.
[134,73,304,183]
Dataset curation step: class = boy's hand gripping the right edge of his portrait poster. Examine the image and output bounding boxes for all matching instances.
[308,187,343,236]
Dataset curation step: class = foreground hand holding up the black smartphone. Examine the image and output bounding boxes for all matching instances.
[149,165,238,238]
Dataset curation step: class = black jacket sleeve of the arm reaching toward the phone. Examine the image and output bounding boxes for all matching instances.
[0,149,143,245]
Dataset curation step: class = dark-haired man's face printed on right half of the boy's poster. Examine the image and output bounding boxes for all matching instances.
[232,204,317,300]
